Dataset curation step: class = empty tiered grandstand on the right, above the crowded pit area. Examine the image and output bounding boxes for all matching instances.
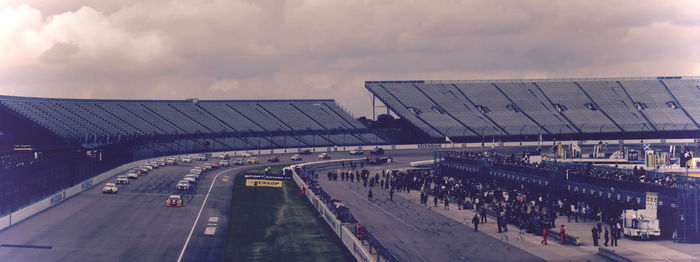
[365,77,700,140]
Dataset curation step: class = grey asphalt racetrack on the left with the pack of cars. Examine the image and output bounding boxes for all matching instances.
[0,154,315,262]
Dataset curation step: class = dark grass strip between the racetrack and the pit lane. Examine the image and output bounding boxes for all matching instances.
[224,165,354,261]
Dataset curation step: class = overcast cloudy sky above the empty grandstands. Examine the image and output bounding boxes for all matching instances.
[0,0,700,117]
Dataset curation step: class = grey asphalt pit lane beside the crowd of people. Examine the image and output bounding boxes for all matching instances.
[308,150,543,261]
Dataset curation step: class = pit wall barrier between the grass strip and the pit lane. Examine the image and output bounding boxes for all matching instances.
[293,159,399,262]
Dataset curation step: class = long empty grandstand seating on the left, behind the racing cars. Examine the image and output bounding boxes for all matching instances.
[0,96,386,148]
